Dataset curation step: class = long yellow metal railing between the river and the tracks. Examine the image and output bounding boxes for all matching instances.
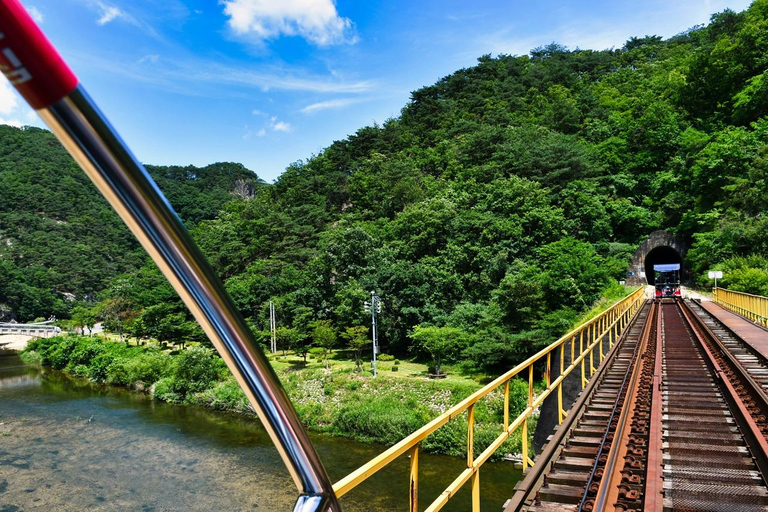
[333,288,644,512]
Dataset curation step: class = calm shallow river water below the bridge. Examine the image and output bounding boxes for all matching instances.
[0,350,520,512]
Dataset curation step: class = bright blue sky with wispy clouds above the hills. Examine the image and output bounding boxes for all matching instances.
[0,0,750,181]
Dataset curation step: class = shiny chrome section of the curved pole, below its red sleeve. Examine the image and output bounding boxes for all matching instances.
[38,86,340,512]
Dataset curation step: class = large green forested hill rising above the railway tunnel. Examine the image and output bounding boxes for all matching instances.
[1,0,768,369]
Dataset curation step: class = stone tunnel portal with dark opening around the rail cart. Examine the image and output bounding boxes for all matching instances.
[626,231,688,286]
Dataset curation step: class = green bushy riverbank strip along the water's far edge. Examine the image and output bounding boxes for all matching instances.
[22,335,533,457]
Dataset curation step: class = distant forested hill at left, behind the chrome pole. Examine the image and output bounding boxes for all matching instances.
[0,125,261,320]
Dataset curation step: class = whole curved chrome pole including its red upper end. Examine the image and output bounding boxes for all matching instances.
[0,0,340,512]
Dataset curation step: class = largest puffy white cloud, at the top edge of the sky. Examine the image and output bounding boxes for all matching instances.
[220,0,357,46]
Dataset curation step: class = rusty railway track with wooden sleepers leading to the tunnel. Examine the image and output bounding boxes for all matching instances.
[505,300,768,512]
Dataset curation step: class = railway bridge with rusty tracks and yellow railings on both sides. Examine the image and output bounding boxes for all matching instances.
[333,288,768,512]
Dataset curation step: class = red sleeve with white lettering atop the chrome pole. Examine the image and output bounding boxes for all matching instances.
[0,0,77,110]
